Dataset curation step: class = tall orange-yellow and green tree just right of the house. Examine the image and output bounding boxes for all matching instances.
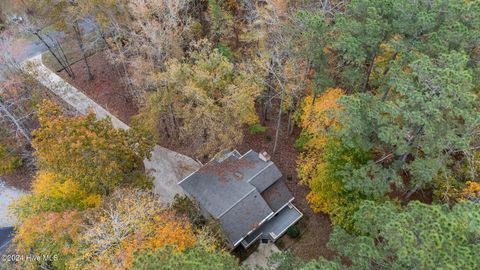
[297,88,365,228]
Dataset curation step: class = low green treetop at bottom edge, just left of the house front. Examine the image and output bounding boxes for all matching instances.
[133,245,239,270]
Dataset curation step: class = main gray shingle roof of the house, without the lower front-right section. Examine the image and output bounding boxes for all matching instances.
[179,151,293,246]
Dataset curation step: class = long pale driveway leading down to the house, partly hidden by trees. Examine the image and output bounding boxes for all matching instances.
[23,55,200,204]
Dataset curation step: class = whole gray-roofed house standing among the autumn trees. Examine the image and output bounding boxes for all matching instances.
[179,150,302,249]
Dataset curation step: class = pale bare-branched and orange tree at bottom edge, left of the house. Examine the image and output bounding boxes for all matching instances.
[71,189,197,269]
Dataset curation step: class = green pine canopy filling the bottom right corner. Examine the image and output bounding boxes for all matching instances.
[329,201,480,269]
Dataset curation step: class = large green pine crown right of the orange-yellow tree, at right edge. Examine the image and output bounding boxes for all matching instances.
[337,52,480,196]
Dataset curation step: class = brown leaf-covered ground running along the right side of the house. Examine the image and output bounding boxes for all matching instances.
[237,104,334,259]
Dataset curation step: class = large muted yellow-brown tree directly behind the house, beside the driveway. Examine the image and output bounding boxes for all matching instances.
[137,41,261,158]
